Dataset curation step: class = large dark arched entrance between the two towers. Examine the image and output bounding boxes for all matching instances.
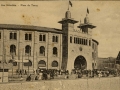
[74,55,87,69]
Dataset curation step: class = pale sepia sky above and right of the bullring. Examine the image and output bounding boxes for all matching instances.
[0,0,120,57]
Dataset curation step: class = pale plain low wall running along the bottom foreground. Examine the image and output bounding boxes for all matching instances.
[0,77,120,90]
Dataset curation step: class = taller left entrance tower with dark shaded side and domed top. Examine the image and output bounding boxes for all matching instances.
[58,10,78,70]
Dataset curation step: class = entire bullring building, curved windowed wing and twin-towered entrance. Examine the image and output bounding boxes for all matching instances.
[0,10,98,71]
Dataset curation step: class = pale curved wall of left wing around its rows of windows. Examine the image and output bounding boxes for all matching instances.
[0,25,62,69]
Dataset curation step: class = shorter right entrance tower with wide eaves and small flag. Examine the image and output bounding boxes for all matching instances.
[78,8,96,69]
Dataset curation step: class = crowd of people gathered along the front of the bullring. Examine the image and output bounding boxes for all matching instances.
[26,69,120,81]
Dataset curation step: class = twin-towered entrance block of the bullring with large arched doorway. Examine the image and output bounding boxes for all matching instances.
[59,11,98,71]
